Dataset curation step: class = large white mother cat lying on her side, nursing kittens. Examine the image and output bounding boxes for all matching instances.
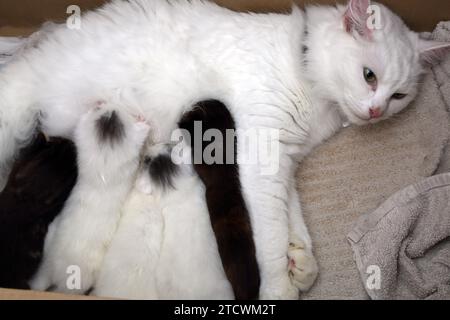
[0,0,449,299]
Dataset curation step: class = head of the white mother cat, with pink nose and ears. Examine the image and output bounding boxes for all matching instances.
[306,0,450,125]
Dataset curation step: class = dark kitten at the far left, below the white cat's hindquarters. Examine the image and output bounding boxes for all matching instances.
[0,134,77,289]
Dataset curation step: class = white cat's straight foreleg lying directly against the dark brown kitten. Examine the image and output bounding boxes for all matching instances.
[238,160,299,299]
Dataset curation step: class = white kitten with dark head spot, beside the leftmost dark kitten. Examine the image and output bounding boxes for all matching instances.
[30,101,149,293]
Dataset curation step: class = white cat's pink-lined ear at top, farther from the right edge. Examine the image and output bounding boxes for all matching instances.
[344,0,372,39]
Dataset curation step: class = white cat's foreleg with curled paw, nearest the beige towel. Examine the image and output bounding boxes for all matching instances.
[288,184,319,291]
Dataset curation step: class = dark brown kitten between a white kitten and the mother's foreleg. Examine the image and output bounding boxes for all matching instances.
[179,100,260,300]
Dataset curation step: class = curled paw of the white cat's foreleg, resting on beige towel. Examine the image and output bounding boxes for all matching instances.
[288,242,319,292]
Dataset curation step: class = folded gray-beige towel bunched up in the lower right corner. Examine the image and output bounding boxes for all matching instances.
[348,173,450,299]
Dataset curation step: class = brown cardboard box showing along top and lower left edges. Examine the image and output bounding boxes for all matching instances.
[0,0,450,300]
